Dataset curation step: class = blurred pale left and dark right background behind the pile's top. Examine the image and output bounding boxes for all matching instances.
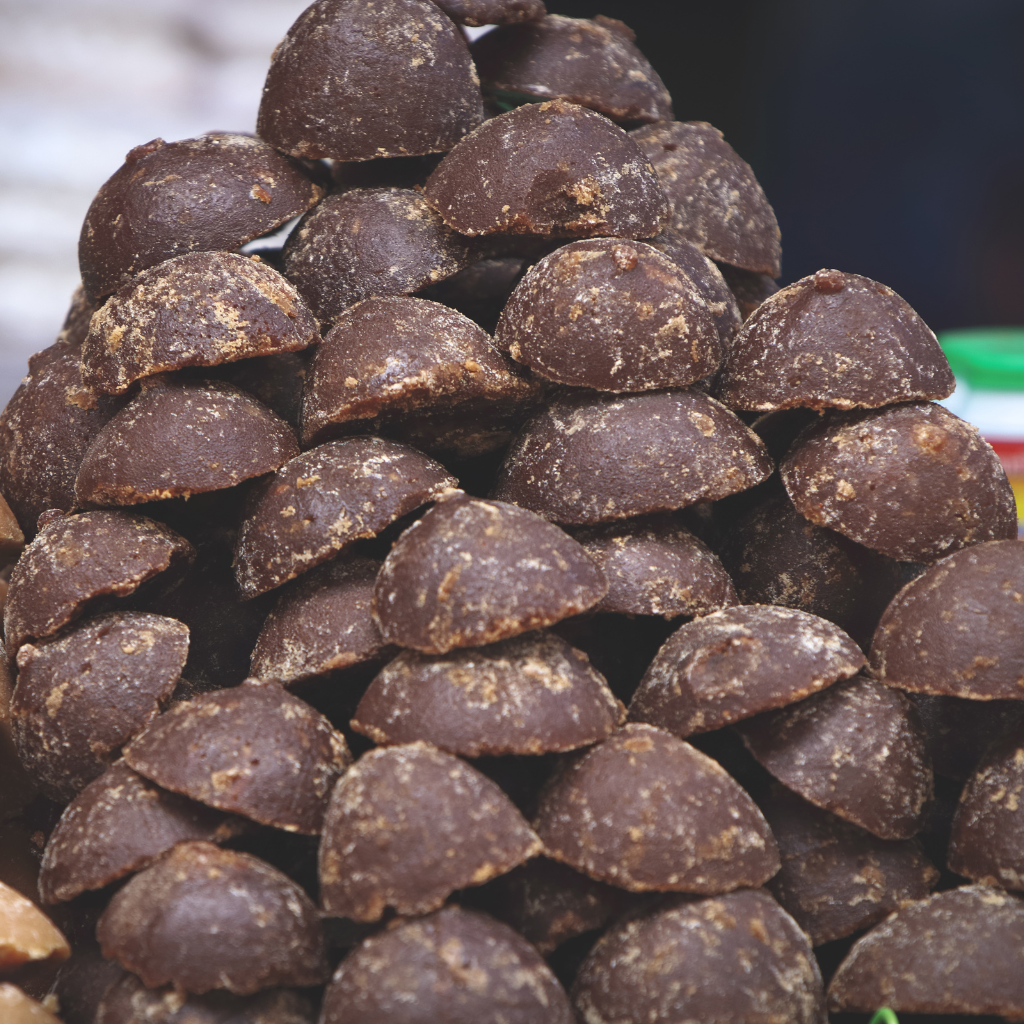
[0,0,1024,404]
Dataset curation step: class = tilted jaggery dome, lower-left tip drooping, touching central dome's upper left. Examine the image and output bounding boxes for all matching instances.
[234,437,458,597]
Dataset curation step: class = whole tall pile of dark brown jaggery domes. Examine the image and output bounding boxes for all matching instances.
[0,0,1024,1024]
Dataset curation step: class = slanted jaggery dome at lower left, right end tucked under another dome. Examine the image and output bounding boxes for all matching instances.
[39,761,241,903]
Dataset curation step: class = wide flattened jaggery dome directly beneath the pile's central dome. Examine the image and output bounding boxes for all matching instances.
[352,633,626,758]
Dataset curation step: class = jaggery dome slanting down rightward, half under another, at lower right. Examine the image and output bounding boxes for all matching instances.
[736,677,932,839]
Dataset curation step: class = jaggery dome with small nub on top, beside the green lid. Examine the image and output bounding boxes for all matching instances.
[715,270,954,412]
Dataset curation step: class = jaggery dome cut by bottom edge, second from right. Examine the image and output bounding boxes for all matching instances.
[572,892,827,1024]
